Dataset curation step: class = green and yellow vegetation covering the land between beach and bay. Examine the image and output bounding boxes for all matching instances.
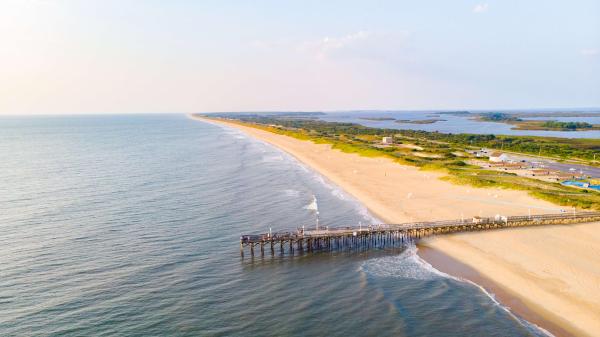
[202,115,600,210]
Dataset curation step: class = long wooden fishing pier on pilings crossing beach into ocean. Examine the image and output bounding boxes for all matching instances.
[240,212,600,257]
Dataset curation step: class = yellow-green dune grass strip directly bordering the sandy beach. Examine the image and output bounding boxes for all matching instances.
[218,117,600,210]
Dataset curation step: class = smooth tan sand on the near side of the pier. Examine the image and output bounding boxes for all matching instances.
[425,223,600,336]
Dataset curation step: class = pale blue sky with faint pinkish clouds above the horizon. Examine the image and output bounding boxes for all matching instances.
[0,0,600,114]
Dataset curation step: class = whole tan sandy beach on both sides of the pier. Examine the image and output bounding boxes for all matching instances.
[199,117,600,336]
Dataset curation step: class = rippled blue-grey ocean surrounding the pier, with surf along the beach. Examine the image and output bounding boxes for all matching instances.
[0,115,544,336]
